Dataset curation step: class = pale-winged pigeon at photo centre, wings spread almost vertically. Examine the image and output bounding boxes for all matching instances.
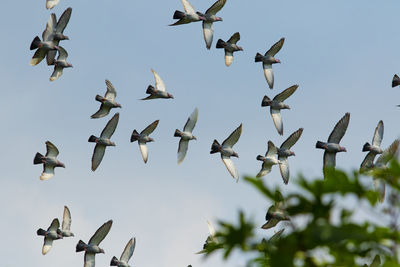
[174,108,199,164]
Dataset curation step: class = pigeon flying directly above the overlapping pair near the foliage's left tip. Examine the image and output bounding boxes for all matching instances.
[261,84,299,135]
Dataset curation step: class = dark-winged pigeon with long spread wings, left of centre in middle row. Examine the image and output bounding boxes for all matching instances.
[88,113,119,171]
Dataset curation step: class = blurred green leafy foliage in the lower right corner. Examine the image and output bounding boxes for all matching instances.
[203,160,400,267]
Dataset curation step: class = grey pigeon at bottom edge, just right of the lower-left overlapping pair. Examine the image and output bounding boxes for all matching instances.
[75,220,112,267]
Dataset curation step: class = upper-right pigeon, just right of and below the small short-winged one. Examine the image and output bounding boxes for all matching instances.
[255,38,285,89]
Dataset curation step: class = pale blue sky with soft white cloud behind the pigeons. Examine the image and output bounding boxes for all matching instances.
[0,0,400,267]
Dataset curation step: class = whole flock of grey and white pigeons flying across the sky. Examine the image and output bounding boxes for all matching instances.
[30,0,400,267]
